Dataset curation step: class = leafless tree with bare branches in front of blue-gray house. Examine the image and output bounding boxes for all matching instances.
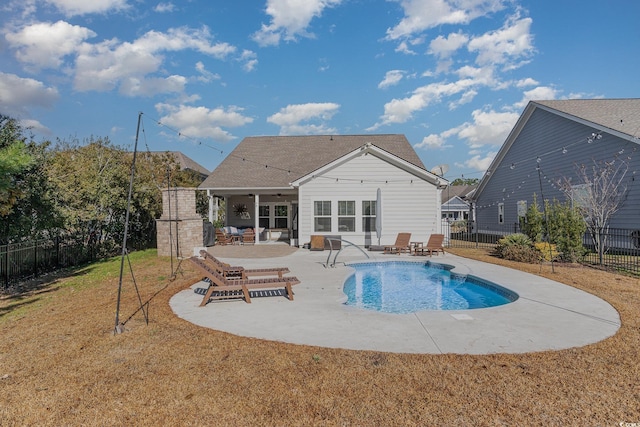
[562,157,629,264]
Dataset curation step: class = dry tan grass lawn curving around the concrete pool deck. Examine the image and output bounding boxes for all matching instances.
[0,250,640,426]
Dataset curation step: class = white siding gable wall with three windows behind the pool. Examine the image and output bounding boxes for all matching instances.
[299,154,440,245]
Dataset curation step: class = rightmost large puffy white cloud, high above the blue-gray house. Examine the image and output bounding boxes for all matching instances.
[468,16,534,69]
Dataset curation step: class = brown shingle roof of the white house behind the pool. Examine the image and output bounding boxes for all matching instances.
[199,135,425,189]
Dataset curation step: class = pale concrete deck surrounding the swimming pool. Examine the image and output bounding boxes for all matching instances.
[170,249,620,354]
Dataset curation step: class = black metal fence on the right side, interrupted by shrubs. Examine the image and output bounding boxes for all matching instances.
[442,220,640,274]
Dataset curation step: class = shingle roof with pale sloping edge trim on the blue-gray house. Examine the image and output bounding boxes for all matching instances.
[473,98,640,198]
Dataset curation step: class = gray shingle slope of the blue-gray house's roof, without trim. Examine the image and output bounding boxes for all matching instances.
[534,98,640,137]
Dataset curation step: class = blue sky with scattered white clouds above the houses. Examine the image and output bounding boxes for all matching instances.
[0,0,640,179]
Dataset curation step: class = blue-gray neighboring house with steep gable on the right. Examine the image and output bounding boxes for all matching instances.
[473,99,640,241]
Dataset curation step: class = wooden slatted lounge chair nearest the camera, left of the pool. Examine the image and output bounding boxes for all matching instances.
[189,256,300,307]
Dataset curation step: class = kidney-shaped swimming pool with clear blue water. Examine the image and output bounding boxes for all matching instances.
[343,261,518,314]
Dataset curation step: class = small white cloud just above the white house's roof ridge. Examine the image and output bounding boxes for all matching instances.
[267,102,340,135]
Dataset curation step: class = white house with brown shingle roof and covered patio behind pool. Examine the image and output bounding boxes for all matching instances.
[199,135,448,246]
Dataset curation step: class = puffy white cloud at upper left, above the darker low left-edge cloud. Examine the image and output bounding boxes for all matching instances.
[5,21,96,69]
